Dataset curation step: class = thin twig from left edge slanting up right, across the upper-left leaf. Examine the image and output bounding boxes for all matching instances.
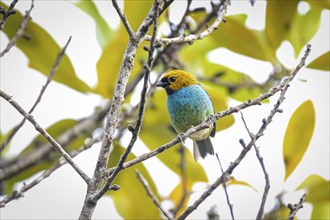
[0,36,71,153]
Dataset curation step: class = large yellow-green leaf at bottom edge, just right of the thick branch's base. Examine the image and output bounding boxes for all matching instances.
[107,142,160,219]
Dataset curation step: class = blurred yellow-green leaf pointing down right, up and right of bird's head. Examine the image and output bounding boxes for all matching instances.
[210,14,275,62]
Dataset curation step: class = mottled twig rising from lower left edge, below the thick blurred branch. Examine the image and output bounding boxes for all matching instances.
[0,136,102,208]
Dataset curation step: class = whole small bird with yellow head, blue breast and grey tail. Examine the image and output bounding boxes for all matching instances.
[156,70,216,161]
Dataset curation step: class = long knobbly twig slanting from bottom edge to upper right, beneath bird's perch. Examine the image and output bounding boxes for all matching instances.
[177,44,311,220]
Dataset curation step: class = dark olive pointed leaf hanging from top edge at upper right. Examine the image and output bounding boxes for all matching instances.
[265,0,299,54]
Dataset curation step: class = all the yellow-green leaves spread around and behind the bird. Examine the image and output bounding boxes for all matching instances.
[1,0,330,219]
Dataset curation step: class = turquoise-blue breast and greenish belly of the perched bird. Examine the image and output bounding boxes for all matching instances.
[167,84,214,132]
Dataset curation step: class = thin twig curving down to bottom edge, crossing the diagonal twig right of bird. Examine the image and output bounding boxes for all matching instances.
[240,112,270,219]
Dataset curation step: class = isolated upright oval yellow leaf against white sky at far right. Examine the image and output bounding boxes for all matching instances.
[283,100,315,179]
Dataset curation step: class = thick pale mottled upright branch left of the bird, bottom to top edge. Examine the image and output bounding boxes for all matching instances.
[79,0,169,219]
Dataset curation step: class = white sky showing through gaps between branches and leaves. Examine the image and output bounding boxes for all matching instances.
[0,1,330,219]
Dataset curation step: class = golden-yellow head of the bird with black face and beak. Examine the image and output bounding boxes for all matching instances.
[156,70,198,95]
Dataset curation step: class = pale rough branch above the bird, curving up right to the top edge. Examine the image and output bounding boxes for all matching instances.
[145,0,229,45]
